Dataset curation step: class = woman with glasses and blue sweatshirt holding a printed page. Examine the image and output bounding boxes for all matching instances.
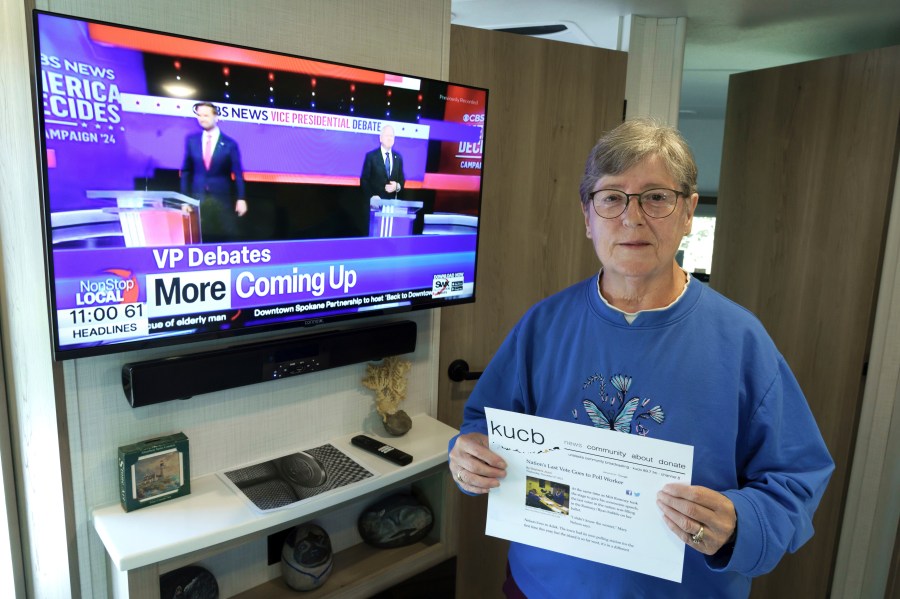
[449,119,834,599]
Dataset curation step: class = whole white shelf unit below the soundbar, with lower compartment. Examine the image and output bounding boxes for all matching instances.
[93,414,457,598]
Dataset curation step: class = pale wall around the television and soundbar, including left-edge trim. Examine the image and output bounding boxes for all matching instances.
[0,0,450,599]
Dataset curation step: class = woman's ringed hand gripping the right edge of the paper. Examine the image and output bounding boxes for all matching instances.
[656,483,737,555]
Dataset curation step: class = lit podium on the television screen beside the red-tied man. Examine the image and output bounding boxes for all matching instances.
[73,190,200,247]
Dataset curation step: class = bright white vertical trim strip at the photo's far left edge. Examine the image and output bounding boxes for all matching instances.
[0,0,73,599]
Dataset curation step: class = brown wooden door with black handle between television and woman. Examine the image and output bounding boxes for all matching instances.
[438,26,626,597]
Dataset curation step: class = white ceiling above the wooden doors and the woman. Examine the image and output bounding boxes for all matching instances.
[451,0,900,119]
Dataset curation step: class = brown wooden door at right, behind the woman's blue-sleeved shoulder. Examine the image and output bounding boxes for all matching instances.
[710,47,900,598]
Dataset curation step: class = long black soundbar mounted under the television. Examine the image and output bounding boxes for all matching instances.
[122,320,416,408]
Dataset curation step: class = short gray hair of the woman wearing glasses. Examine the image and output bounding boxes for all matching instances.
[580,118,697,206]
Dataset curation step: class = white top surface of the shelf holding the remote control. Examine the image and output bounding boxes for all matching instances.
[93,414,458,571]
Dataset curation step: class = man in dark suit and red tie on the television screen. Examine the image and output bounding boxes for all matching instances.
[181,102,247,243]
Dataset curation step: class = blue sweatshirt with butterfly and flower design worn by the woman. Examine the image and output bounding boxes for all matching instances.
[450,275,834,599]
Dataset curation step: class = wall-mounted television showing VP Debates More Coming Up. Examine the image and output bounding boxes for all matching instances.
[34,11,488,359]
